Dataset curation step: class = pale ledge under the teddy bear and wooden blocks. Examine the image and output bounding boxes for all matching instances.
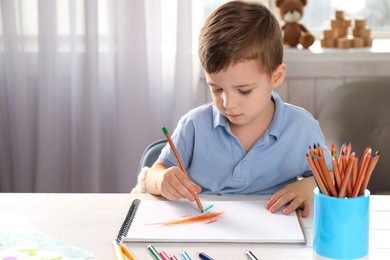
[284,39,390,78]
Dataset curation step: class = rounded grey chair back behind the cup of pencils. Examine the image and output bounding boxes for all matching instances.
[318,80,390,194]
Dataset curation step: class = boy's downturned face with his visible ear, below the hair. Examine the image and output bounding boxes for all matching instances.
[206,60,285,125]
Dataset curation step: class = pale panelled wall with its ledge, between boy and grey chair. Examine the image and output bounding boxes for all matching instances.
[277,40,390,117]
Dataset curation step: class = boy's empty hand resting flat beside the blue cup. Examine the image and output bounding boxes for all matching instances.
[265,177,316,217]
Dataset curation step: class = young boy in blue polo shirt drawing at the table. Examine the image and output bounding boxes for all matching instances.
[146,1,330,217]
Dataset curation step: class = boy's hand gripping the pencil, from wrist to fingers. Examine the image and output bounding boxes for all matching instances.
[156,166,201,201]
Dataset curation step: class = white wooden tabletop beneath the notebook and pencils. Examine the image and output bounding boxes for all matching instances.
[0,193,390,260]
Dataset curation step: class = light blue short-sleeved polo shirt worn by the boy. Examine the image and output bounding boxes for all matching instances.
[159,92,331,194]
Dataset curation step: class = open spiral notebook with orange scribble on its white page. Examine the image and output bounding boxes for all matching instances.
[117,199,306,243]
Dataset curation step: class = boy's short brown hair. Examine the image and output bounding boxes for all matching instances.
[199,1,283,74]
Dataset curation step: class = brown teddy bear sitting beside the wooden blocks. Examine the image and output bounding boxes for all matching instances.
[275,0,315,49]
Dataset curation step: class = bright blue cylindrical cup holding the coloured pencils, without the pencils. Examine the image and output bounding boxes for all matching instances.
[313,188,370,259]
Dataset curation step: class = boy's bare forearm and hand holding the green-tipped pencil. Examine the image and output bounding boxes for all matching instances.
[146,160,201,201]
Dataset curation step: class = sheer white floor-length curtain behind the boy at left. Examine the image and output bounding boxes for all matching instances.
[0,0,205,192]
